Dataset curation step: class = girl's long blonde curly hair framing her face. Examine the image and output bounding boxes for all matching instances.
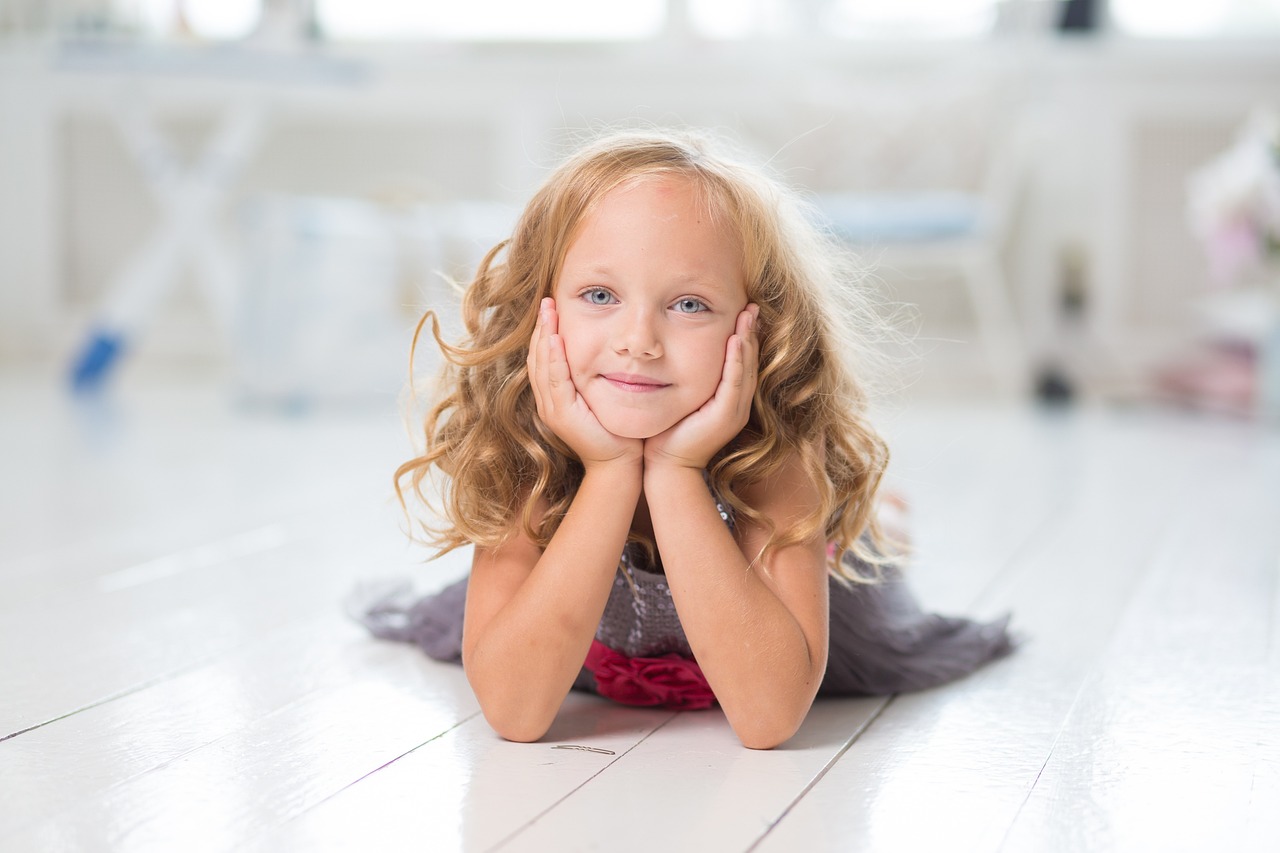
[394,132,888,580]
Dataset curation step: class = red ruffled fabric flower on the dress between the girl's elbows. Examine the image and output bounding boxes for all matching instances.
[585,640,716,711]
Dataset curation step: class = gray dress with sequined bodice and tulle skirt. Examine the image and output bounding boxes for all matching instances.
[348,499,1014,695]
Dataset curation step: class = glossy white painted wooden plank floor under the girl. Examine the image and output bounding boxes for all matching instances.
[0,361,1280,853]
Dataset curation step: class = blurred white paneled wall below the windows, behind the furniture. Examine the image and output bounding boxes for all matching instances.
[0,34,1280,386]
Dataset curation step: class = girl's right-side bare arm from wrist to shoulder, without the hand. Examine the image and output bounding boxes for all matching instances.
[645,465,828,749]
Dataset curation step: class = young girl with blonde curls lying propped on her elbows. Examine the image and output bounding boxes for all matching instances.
[362,126,1010,748]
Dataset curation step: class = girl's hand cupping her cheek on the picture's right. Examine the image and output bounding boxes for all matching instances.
[644,304,760,470]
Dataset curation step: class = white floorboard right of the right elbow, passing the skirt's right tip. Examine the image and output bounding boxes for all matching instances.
[759,409,1203,852]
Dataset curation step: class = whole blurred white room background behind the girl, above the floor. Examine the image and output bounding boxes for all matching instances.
[0,0,1280,418]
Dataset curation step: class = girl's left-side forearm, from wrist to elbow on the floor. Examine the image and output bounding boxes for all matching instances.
[463,465,640,740]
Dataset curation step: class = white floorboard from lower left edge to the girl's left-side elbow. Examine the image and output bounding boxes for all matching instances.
[0,615,479,847]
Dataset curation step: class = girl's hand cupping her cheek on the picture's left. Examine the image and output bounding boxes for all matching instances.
[526,297,644,466]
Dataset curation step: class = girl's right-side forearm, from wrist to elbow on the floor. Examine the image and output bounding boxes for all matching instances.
[645,467,826,747]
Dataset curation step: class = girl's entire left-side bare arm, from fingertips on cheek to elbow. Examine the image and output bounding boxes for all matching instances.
[462,300,644,740]
